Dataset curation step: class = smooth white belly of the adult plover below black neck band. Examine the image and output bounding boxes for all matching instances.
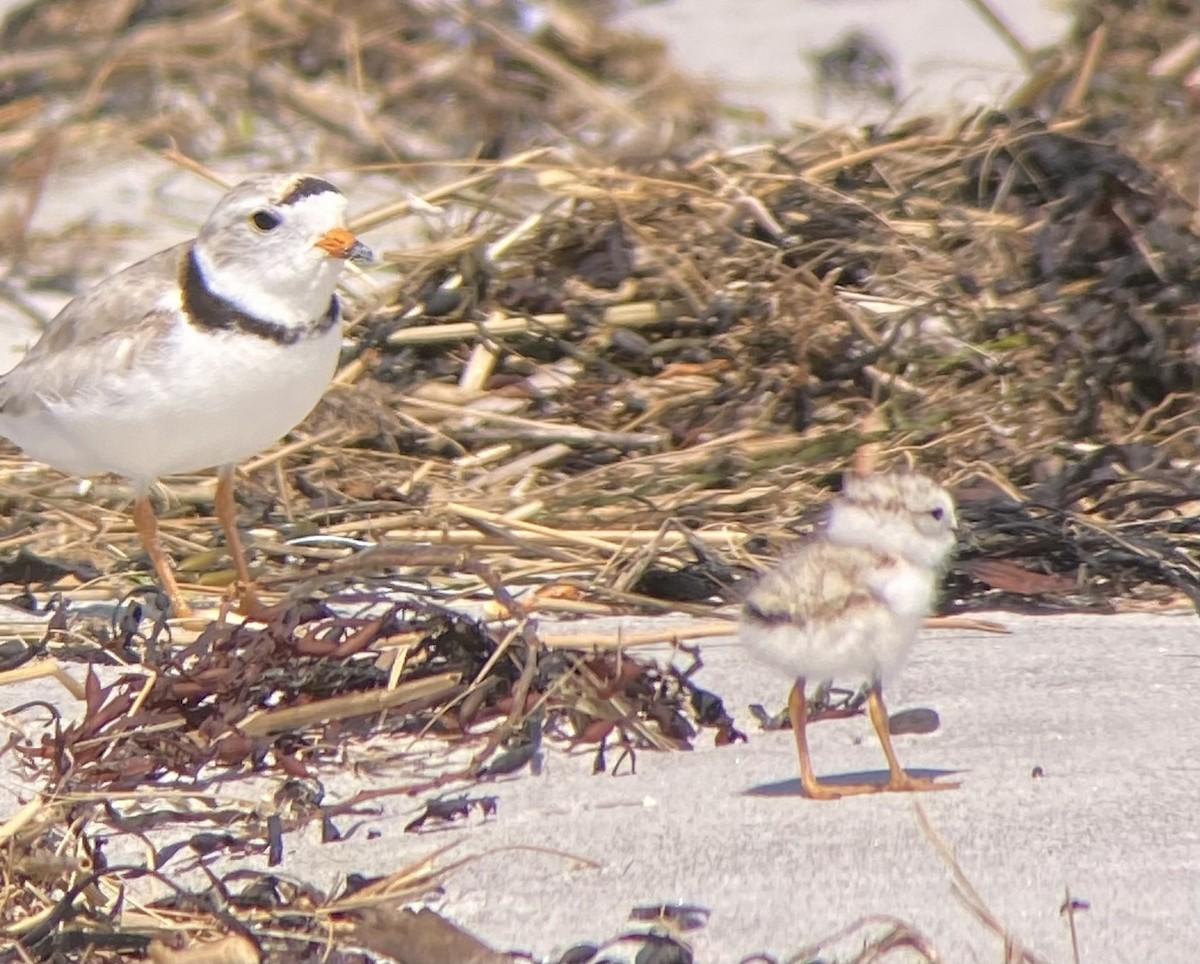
[0,324,341,487]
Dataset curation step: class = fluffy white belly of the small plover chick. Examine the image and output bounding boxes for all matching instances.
[740,605,920,683]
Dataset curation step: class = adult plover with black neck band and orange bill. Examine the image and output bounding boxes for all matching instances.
[0,174,371,615]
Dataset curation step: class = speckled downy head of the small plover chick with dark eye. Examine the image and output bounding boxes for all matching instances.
[826,472,959,569]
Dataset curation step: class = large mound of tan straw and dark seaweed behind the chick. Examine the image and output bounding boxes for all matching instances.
[319,114,1200,605]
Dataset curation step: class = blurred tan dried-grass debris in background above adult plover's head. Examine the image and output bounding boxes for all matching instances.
[0,0,715,167]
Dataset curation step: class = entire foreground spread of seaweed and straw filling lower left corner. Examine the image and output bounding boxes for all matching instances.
[0,581,745,960]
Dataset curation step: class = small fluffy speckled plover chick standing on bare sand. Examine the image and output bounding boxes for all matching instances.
[740,472,958,800]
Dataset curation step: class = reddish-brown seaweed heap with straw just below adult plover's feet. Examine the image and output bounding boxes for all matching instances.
[7,593,744,794]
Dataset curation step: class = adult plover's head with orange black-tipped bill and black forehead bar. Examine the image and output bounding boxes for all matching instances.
[194,174,372,327]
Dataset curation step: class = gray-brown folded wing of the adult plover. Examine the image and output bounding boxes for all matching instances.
[0,241,191,415]
